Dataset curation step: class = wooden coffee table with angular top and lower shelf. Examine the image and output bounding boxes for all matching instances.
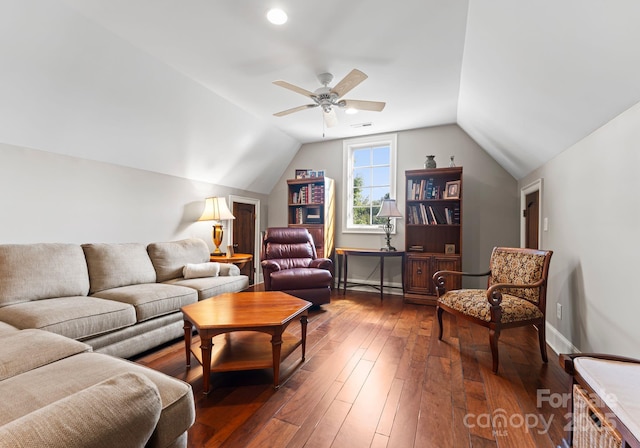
[181,291,312,394]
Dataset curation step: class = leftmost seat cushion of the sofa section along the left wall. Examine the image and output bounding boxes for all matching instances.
[0,296,136,339]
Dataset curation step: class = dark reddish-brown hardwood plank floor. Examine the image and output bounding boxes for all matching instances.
[135,291,571,448]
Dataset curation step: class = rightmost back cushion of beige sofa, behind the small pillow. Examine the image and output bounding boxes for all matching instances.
[147,238,210,282]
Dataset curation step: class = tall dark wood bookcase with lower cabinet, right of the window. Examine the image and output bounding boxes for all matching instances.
[404,167,463,305]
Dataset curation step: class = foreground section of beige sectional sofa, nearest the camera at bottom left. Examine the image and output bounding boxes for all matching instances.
[0,323,195,448]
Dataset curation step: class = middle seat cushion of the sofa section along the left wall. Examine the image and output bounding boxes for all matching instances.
[93,283,198,322]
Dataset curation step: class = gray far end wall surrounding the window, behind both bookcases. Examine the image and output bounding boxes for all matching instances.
[268,125,519,286]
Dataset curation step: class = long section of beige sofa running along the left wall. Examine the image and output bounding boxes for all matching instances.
[0,238,249,358]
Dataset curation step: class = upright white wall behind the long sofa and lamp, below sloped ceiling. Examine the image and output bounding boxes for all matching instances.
[0,144,267,249]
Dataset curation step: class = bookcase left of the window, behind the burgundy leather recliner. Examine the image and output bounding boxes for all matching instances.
[287,177,335,258]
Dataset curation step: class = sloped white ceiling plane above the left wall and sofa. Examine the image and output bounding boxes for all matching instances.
[0,0,300,192]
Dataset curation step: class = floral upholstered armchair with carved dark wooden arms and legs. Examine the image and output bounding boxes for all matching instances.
[433,247,553,373]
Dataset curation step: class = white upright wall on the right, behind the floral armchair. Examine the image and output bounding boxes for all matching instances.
[519,103,640,357]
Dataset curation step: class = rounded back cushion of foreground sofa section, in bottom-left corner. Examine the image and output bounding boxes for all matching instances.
[0,372,162,448]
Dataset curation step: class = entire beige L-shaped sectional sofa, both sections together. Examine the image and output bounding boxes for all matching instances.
[0,238,248,448]
